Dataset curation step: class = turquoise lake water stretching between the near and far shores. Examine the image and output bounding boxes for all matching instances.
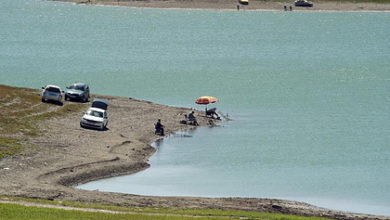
[0,0,390,215]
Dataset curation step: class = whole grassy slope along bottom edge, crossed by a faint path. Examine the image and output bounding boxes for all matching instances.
[0,201,332,220]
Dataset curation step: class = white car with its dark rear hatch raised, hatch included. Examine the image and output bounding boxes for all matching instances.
[80,99,108,130]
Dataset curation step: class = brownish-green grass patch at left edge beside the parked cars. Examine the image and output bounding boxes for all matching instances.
[0,85,85,158]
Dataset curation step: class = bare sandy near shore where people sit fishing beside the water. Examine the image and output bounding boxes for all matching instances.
[0,87,389,219]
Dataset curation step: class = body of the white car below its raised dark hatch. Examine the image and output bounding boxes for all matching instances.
[80,107,108,130]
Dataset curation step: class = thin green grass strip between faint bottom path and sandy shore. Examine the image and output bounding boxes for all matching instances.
[0,196,336,220]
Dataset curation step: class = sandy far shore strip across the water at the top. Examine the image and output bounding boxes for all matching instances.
[50,0,390,12]
